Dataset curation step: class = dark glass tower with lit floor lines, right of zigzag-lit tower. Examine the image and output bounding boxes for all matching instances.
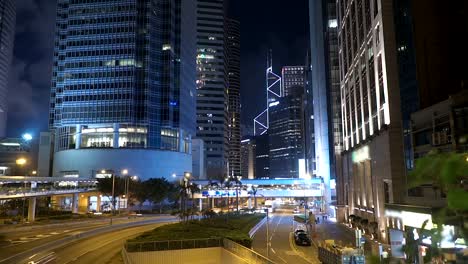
[268,85,305,178]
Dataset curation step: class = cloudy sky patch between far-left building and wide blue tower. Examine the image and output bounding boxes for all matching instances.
[7,0,56,137]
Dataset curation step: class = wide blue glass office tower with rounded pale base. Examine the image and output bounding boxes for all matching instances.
[50,0,196,179]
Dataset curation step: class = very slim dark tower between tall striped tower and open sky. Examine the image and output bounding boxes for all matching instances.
[226,19,241,176]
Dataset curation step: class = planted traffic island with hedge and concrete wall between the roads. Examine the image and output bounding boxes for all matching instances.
[122,214,274,264]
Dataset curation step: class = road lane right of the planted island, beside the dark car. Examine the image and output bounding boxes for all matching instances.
[252,212,319,264]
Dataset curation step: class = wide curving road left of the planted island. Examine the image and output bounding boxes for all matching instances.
[0,216,176,263]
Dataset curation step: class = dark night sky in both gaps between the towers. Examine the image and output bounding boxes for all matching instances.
[7,0,309,137]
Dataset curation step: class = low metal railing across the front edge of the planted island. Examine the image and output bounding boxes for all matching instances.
[125,238,223,252]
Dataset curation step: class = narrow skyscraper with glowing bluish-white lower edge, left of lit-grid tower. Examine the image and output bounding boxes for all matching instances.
[310,0,343,210]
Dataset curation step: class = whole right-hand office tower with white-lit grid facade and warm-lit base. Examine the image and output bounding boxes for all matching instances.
[334,0,406,241]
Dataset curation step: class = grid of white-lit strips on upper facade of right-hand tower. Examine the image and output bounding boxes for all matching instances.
[339,0,390,150]
